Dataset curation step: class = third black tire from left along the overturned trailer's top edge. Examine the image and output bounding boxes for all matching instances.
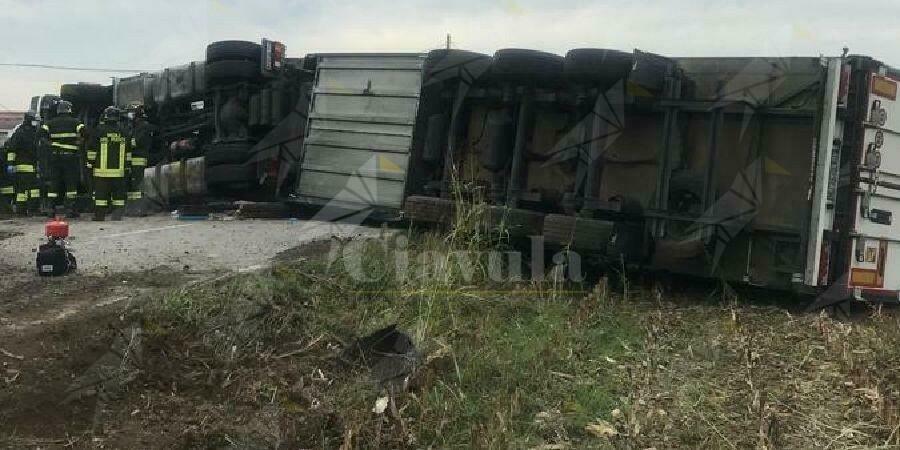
[563,48,634,86]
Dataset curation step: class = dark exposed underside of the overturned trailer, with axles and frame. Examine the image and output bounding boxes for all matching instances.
[398,50,824,287]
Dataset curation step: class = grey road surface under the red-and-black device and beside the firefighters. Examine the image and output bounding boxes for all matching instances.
[0,215,376,274]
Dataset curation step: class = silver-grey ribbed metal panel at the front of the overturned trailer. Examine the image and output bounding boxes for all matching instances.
[297,54,424,209]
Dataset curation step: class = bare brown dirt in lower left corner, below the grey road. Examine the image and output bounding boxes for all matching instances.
[0,266,186,448]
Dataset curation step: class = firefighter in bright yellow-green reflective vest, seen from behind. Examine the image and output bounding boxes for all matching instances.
[88,106,131,221]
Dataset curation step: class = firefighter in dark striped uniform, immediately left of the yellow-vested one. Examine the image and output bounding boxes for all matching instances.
[41,100,84,217]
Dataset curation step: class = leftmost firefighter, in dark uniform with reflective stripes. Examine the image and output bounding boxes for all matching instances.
[7,112,41,216]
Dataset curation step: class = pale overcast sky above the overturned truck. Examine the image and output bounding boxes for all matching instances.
[0,0,900,110]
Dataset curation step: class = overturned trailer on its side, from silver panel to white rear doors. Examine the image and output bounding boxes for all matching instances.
[296,49,900,303]
